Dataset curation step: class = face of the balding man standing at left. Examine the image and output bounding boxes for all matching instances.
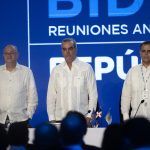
[3,47,18,63]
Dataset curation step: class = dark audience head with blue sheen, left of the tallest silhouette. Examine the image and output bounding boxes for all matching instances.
[34,123,60,150]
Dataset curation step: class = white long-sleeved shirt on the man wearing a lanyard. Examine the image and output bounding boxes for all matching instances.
[121,64,150,120]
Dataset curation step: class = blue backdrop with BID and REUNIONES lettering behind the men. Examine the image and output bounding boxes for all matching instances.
[0,0,150,127]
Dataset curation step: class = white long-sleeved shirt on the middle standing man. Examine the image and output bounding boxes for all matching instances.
[47,58,98,120]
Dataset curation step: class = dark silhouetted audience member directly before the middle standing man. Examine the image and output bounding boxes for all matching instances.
[60,111,99,150]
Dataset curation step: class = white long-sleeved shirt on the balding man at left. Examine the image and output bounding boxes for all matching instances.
[0,64,38,124]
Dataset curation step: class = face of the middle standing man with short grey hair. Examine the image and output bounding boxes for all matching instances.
[62,41,76,64]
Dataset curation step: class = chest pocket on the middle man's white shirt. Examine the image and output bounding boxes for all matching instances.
[74,76,86,87]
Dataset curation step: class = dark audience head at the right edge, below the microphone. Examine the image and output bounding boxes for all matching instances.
[123,117,150,149]
